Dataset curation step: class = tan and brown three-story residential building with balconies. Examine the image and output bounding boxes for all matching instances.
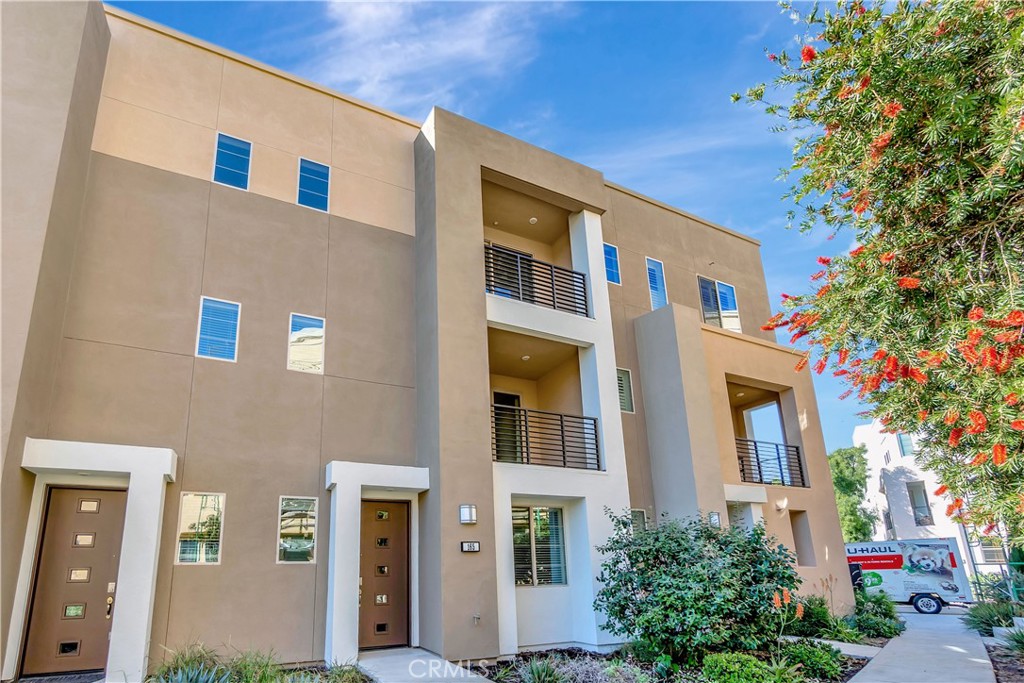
[0,3,852,681]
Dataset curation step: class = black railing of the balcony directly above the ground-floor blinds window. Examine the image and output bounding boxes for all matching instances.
[490,405,601,470]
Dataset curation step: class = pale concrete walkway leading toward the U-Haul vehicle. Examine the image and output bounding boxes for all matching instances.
[850,612,995,683]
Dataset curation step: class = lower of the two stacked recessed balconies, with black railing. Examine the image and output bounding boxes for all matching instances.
[487,328,601,470]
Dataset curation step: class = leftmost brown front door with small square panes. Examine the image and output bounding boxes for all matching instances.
[22,488,128,675]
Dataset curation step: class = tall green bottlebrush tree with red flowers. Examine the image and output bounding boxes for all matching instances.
[733,0,1024,546]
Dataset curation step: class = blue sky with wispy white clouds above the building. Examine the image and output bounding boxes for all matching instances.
[112,0,862,451]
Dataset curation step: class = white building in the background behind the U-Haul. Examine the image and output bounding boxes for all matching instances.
[853,420,1007,573]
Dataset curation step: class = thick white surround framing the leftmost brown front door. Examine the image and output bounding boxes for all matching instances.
[0,438,177,683]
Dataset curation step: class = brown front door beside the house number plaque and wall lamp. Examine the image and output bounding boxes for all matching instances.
[359,501,409,648]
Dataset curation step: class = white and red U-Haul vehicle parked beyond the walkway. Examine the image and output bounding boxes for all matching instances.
[846,539,972,614]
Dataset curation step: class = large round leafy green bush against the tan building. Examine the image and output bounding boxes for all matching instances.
[594,515,800,664]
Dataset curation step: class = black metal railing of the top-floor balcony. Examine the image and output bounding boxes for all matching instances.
[484,245,590,317]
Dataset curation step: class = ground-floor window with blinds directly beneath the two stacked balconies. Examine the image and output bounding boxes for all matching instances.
[512,507,567,586]
